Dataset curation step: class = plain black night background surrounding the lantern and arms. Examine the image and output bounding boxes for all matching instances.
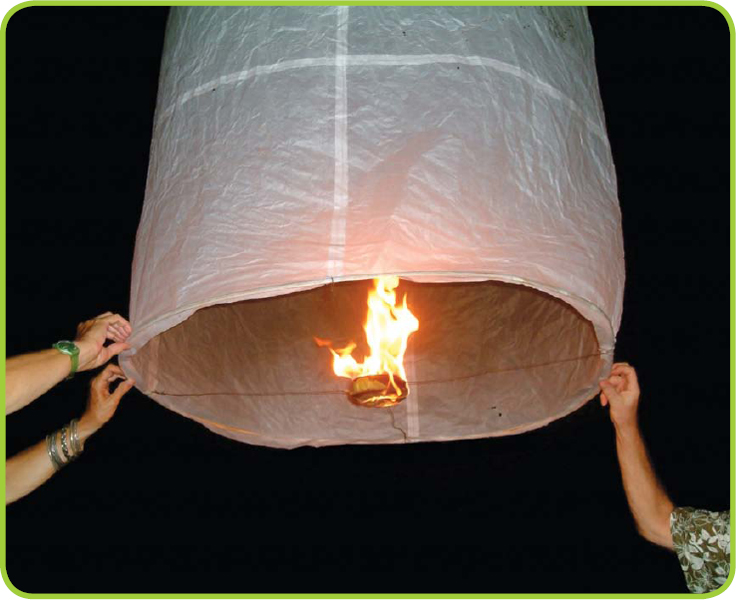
[7,7,729,593]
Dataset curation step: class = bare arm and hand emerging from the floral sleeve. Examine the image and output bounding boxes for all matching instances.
[601,363,674,550]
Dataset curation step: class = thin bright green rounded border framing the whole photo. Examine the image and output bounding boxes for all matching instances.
[0,0,736,599]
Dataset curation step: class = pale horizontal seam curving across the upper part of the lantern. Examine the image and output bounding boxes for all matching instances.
[157,53,607,140]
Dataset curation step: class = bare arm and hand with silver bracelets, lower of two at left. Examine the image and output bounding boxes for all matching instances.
[5,365,134,504]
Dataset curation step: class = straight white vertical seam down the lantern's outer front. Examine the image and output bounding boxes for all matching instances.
[327,6,349,277]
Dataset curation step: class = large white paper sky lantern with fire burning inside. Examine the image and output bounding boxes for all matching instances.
[121,6,624,448]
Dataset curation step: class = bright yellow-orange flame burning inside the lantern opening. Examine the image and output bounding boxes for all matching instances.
[315,275,419,392]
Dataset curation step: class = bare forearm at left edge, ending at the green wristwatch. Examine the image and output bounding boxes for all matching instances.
[5,349,72,415]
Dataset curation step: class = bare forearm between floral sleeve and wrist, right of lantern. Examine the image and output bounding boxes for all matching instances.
[616,425,674,549]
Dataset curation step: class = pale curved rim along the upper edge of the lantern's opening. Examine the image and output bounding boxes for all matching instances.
[126,271,616,354]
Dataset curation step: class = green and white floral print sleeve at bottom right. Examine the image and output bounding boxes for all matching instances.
[670,507,731,594]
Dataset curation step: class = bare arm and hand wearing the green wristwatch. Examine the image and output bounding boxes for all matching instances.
[5,313,131,415]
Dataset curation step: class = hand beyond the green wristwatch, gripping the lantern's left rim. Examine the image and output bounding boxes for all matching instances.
[75,312,132,371]
